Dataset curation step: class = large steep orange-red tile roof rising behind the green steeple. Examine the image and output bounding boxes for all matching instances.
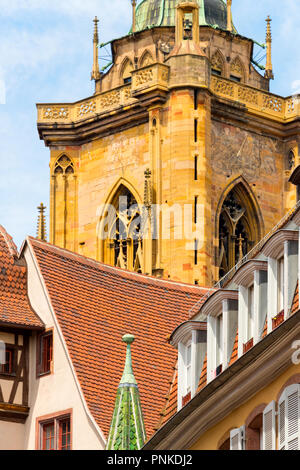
[27,237,206,438]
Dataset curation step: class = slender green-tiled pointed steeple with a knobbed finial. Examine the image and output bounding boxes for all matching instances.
[106,335,146,450]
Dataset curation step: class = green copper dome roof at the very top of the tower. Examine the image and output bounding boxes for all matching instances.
[136,0,236,32]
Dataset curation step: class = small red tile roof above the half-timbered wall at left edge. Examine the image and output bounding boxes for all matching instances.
[0,225,44,329]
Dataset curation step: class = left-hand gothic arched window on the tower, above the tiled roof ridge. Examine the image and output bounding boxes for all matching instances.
[105,185,143,273]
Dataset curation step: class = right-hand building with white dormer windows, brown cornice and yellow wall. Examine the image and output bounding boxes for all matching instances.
[144,204,300,450]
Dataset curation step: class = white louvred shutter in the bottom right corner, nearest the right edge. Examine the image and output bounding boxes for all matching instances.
[279,384,300,450]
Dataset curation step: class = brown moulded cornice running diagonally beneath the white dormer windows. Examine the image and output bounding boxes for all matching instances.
[143,311,300,450]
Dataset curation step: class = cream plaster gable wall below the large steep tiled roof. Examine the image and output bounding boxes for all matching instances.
[24,247,105,450]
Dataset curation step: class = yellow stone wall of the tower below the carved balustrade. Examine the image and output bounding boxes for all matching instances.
[50,79,296,286]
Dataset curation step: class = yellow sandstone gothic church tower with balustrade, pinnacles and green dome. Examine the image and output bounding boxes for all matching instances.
[38,0,300,286]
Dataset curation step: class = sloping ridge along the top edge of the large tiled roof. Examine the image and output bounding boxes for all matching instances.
[27,236,209,294]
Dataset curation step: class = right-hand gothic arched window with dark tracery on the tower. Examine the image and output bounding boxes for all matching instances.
[218,185,261,278]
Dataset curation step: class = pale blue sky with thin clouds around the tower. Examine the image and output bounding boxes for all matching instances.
[0,0,300,247]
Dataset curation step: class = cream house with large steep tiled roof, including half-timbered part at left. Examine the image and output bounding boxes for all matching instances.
[0,226,207,450]
